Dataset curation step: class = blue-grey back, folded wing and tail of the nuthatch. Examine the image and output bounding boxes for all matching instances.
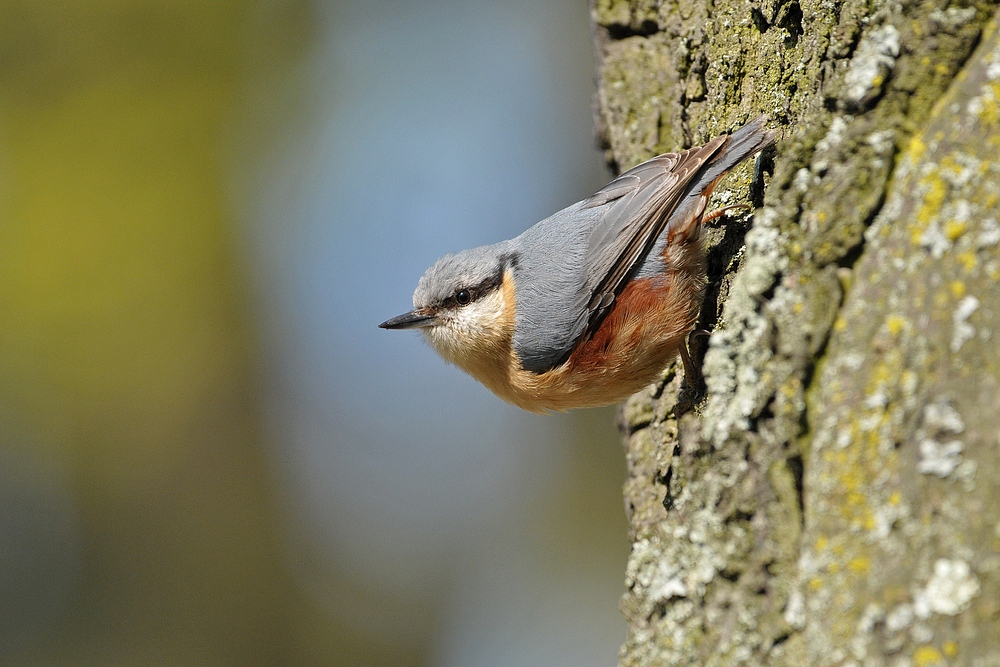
[513,116,775,373]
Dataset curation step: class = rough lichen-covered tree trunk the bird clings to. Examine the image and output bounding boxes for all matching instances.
[593,0,1000,667]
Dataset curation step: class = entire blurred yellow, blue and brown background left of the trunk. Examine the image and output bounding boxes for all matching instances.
[0,0,628,667]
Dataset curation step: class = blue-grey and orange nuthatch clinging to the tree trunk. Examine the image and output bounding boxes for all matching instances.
[379,116,775,412]
